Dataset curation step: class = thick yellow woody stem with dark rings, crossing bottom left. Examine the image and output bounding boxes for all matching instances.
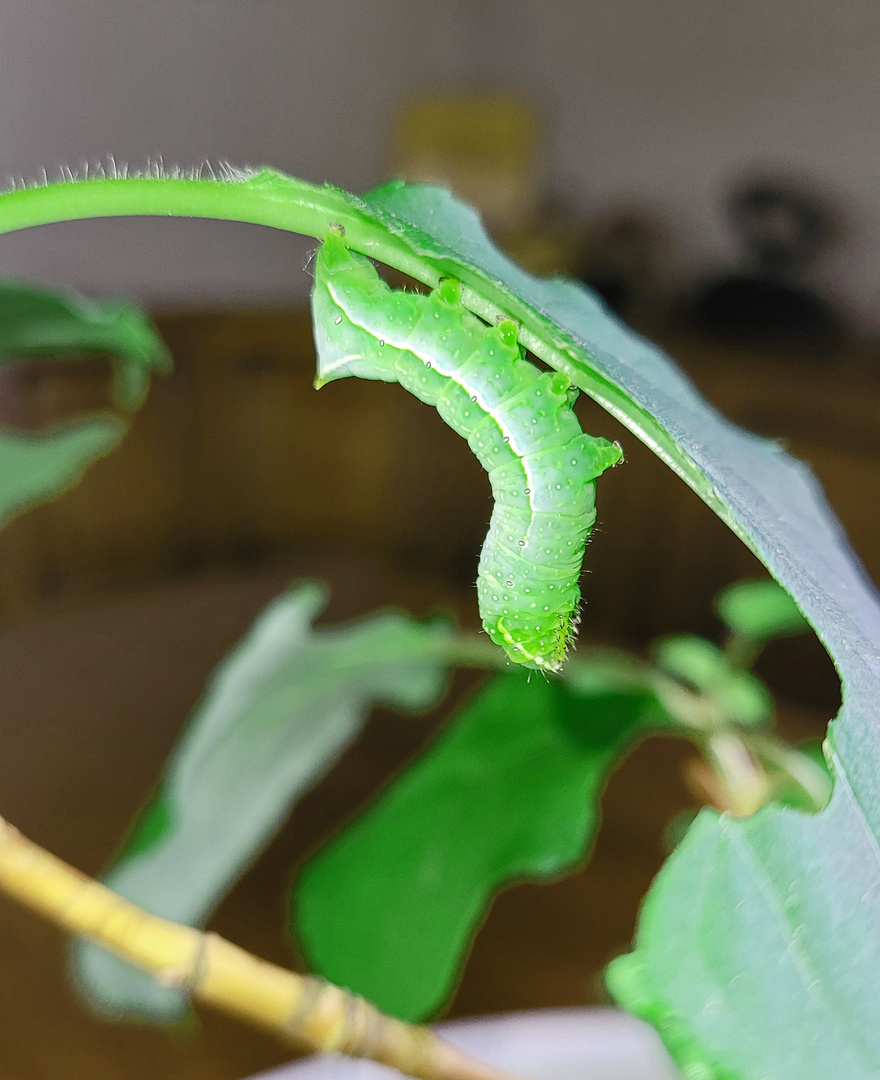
[0,819,522,1080]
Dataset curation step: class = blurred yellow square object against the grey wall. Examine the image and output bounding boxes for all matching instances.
[392,93,541,240]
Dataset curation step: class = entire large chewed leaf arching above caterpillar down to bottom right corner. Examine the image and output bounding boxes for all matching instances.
[354,185,880,1080]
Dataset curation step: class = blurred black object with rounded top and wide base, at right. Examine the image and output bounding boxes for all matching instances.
[689,179,845,352]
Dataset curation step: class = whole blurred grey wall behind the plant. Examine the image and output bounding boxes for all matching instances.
[0,0,880,322]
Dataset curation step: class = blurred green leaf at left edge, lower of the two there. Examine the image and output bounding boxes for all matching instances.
[0,416,127,528]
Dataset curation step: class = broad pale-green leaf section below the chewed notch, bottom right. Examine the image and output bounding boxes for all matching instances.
[608,803,880,1080]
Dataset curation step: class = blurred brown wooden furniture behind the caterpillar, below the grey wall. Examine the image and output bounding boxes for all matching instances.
[0,310,880,704]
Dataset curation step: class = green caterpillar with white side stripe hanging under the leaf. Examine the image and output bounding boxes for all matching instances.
[312,232,622,671]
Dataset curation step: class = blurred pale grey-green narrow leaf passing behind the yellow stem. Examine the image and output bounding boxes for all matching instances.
[76,583,451,1021]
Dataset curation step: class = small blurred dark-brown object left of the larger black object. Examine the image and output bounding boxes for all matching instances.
[572,208,668,320]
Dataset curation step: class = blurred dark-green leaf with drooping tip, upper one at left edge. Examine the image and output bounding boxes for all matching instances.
[0,281,171,410]
